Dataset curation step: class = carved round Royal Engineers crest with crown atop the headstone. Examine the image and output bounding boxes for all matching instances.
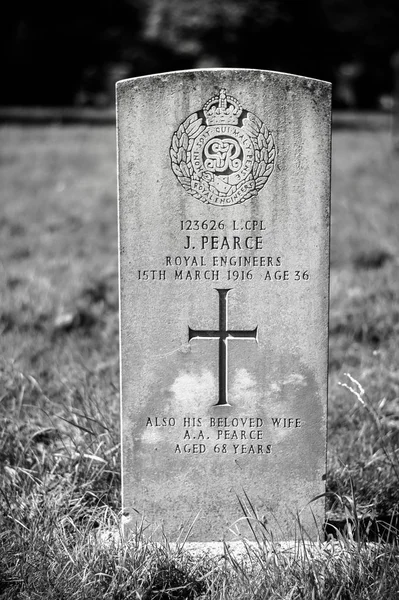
[170,89,276,206]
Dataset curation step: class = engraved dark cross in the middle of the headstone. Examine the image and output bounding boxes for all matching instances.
[188,288,258,406]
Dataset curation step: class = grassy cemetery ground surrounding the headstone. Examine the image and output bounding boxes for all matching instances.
[0,117,399,600]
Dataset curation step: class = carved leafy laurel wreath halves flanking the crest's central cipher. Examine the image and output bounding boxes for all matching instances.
[170,106,276,202]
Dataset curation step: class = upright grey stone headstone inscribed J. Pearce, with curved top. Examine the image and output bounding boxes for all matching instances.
[117,69,331,542]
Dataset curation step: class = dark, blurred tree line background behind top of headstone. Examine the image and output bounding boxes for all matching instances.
[0,0,399,108]
